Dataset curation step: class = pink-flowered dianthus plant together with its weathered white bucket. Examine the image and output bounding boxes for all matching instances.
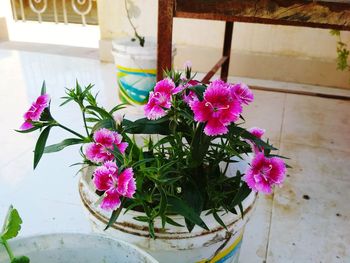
[17,68,286,262]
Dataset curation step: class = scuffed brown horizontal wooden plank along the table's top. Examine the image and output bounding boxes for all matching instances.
[175,0,350,30]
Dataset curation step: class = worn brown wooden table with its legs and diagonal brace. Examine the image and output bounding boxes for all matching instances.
[157,0,350,83]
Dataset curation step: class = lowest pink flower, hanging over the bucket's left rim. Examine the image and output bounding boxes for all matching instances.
[93,161,136,210]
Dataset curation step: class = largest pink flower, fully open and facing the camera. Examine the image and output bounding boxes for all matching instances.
[190,80,242,136]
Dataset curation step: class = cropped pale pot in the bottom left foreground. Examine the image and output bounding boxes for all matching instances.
[0,234,158,263]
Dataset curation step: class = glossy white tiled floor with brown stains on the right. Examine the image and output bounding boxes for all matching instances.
[0,45,350,263]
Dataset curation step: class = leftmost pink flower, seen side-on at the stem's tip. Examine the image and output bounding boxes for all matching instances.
[19,94,50,130]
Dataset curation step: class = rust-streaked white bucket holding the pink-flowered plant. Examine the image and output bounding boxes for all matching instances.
[79,163,256,263]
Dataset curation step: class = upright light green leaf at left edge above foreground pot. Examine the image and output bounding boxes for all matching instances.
[1,205,22,240]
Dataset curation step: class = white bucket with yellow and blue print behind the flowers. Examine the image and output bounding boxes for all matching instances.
[112,37,175,105]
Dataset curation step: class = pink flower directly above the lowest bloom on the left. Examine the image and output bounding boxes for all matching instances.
[85,128,128,163]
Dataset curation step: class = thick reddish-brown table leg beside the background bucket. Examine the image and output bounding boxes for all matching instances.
[157,0,174,81]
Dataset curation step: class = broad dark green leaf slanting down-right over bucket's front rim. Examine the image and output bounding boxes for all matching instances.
[168,196,209,230]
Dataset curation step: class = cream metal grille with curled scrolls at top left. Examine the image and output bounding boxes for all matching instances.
[10,0,98,26]
